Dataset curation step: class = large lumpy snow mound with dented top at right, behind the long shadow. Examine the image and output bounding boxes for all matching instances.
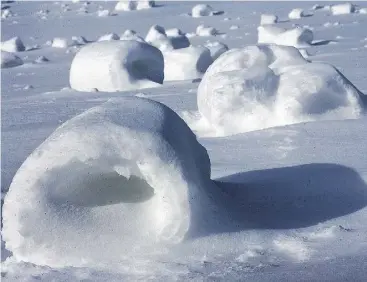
[197,45,363,135]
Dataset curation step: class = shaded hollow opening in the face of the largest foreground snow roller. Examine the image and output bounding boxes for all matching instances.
[49,164,154,207]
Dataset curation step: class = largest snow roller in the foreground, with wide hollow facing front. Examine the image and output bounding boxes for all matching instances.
[2,97,210,267]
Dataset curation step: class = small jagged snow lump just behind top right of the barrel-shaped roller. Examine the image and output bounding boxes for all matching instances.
[145,25,190,51]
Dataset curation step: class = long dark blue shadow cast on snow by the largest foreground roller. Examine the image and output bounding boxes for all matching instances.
[199,164,367,236]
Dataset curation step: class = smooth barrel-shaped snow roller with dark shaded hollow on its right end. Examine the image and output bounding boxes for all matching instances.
[70,40,164,92]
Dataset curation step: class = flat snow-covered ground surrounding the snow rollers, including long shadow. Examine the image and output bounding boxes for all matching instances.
[1,1,367,282]
